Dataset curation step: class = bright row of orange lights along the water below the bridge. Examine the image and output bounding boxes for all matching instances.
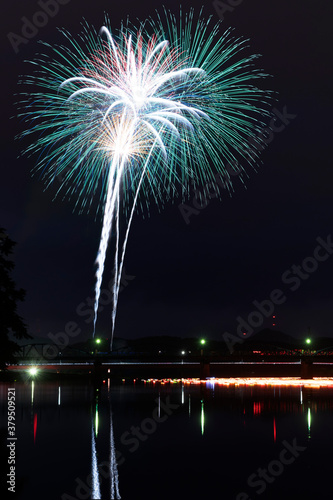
[143,377,333,388]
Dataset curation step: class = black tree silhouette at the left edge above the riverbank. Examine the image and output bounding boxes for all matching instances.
[0,228,32,368]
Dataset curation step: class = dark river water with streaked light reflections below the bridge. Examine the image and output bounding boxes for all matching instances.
[0,377,333,500]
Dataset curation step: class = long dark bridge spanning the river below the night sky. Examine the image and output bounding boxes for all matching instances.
[8,343,333,379]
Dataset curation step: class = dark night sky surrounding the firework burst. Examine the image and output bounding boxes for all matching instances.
[0,0,333,346]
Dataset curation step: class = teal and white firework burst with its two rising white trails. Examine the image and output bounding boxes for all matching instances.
[18,11,268,347]
